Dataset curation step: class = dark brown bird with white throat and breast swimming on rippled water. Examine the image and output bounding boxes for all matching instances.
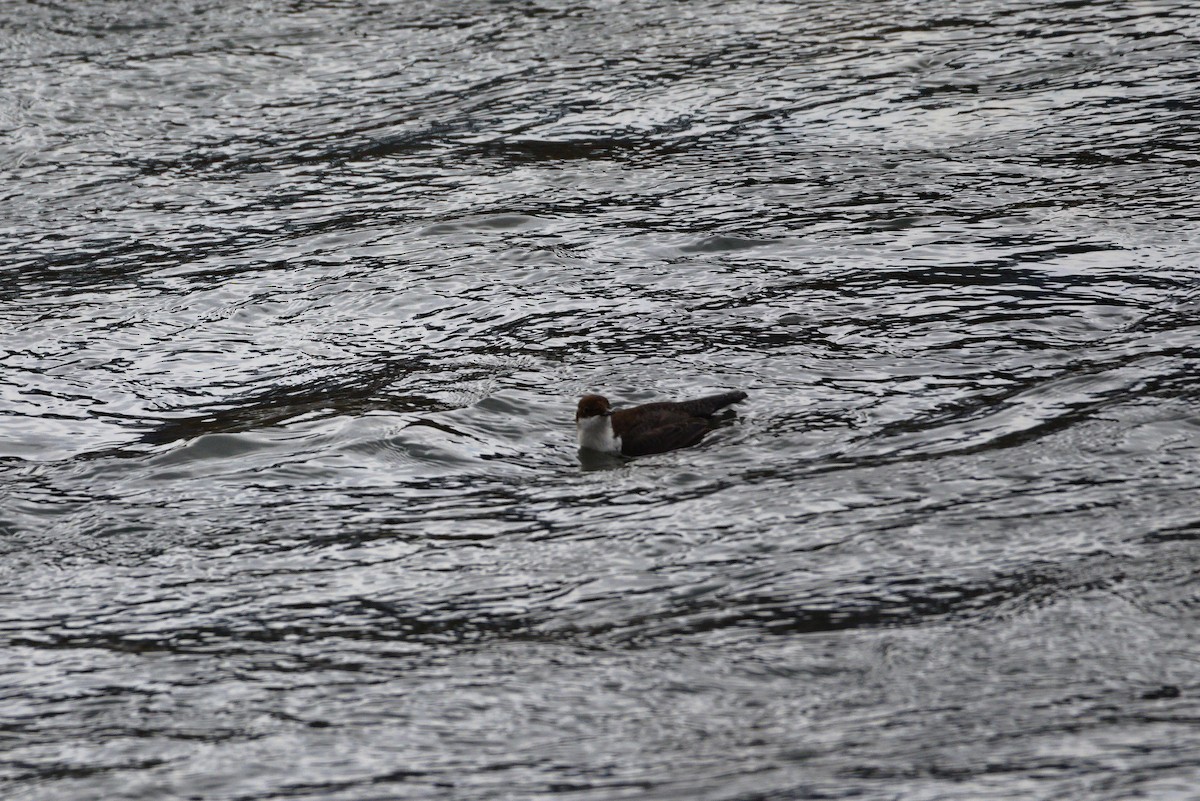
[575,391,746,456]
